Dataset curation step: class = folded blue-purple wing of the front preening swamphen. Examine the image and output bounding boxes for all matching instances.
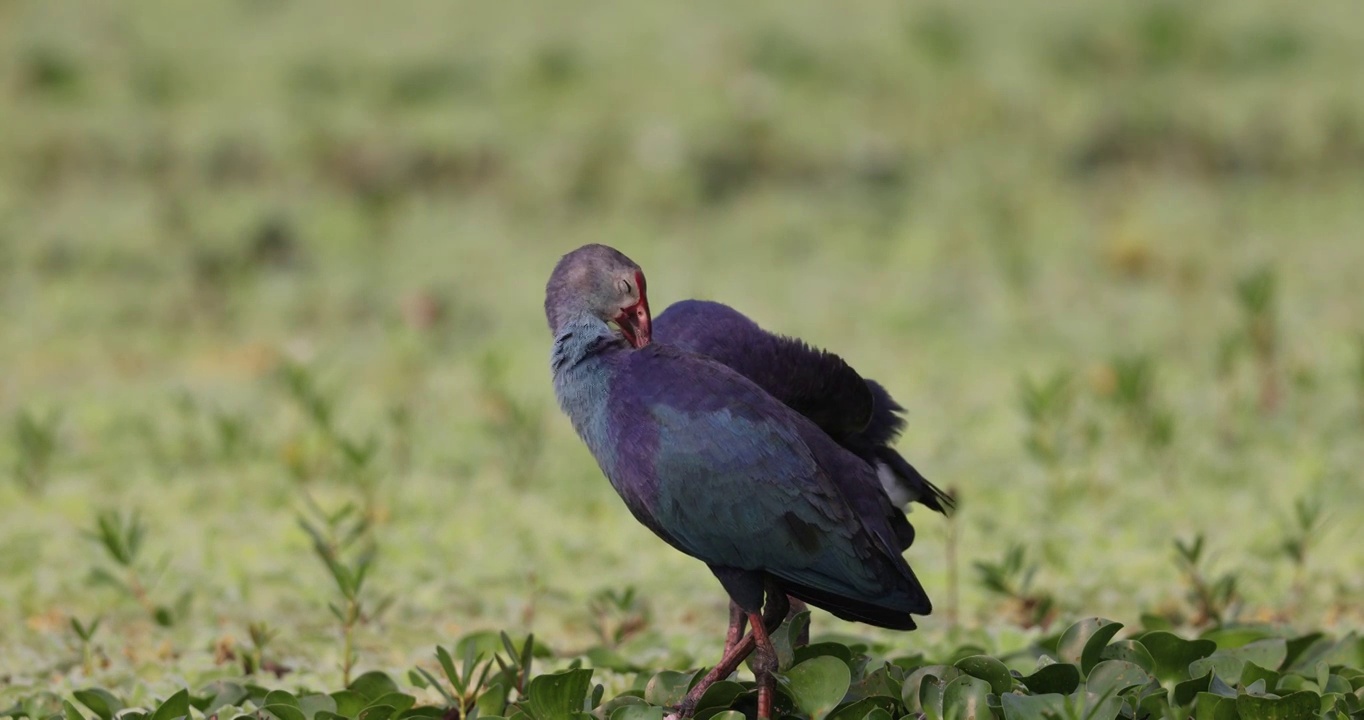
[605,344,932,629]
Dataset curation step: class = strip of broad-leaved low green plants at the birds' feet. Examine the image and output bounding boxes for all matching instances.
[34,618,1364,720]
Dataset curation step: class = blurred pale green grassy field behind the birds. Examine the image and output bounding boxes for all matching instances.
[0,0,1364,706]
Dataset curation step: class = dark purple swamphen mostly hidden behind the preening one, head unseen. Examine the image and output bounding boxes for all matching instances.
[652,300,953,648]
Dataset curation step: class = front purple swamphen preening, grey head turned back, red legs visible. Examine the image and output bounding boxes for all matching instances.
[544,244,932,717]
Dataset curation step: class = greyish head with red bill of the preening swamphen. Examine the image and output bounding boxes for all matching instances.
[544,244,652,348]
